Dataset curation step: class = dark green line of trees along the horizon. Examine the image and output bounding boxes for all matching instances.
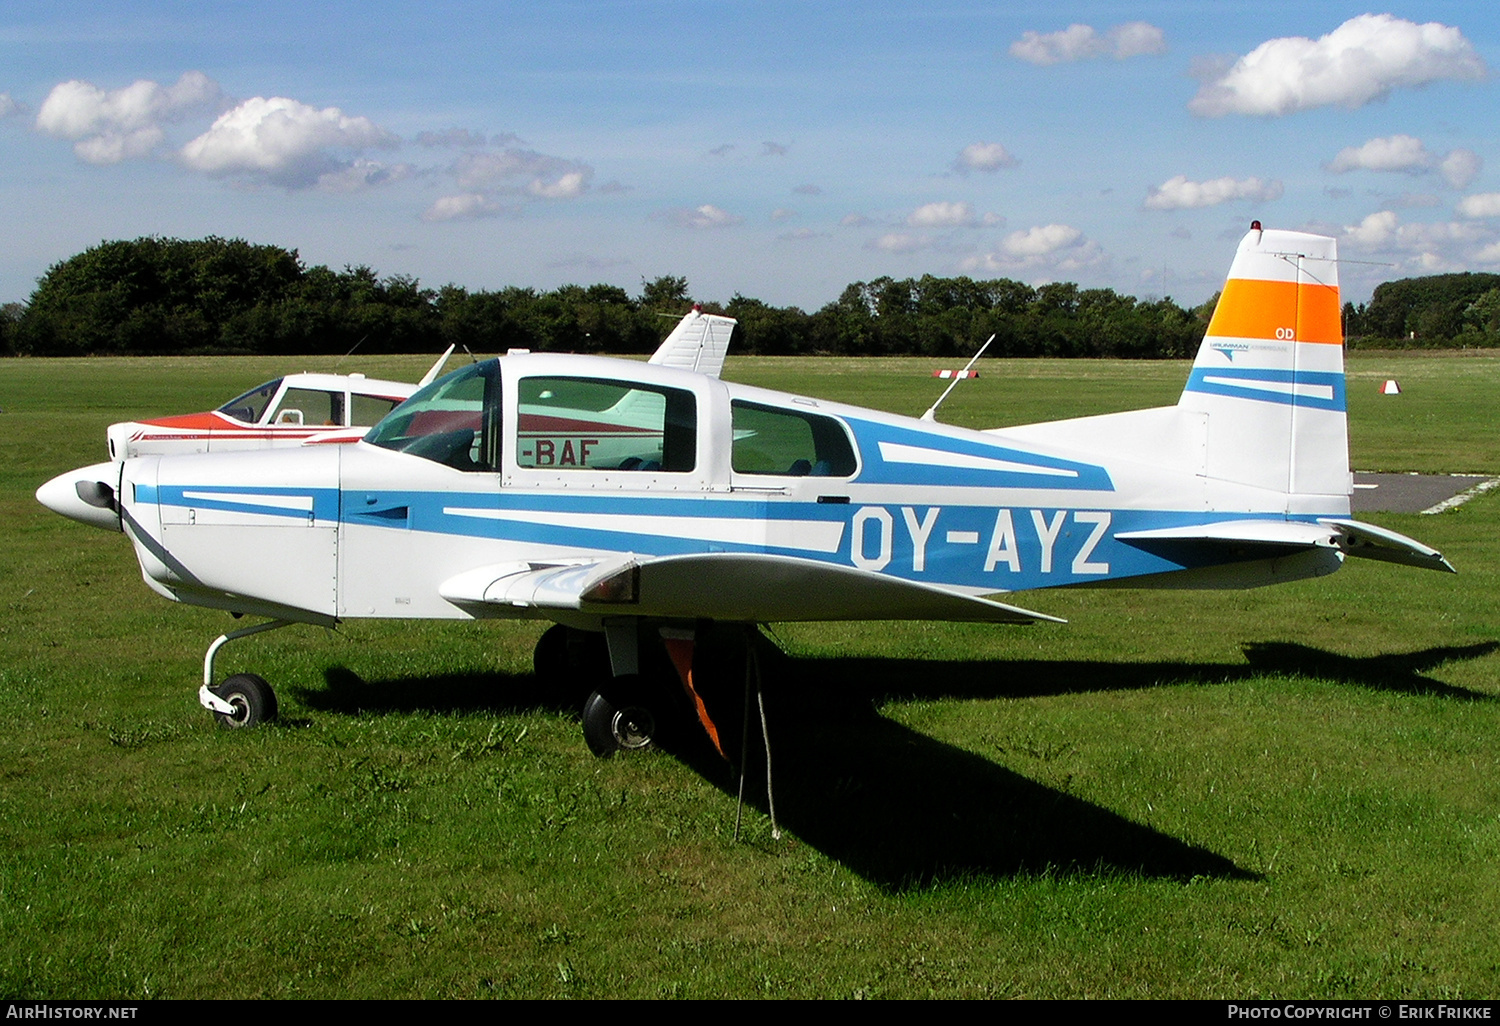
[0,237,1500,359]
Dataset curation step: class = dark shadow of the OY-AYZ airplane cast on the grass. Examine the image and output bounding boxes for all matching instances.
[286,642,1500,891]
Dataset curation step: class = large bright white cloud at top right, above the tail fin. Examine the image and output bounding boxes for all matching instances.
[1188,14,1487,117]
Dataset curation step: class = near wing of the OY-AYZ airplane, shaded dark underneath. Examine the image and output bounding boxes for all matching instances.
[438,552,1067,624]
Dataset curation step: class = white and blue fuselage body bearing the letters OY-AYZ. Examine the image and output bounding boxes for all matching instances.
[90,348,1349,623]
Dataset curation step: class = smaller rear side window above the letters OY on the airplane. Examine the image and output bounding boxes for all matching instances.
[731,399,857,477]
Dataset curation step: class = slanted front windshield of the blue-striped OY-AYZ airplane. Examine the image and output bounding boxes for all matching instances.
[365,360,500,471]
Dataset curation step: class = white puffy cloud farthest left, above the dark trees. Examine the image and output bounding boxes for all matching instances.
[36,71,224,164]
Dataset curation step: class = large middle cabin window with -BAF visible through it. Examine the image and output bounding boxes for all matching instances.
[516,378,698,474]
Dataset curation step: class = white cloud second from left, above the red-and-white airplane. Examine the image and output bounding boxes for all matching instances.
[182,96,396,188]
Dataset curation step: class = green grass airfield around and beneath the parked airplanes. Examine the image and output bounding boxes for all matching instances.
[0,354,1500,999]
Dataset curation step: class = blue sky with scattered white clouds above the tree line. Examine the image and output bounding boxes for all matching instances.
[0,0,1500,309]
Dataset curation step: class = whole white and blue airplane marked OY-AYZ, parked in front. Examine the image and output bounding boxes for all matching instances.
[38,231,1452,755]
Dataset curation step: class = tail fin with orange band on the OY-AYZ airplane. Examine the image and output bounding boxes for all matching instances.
[1178,222,1350,513]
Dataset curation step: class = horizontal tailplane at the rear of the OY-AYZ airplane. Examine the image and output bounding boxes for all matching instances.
[1115,519,1458,573]
